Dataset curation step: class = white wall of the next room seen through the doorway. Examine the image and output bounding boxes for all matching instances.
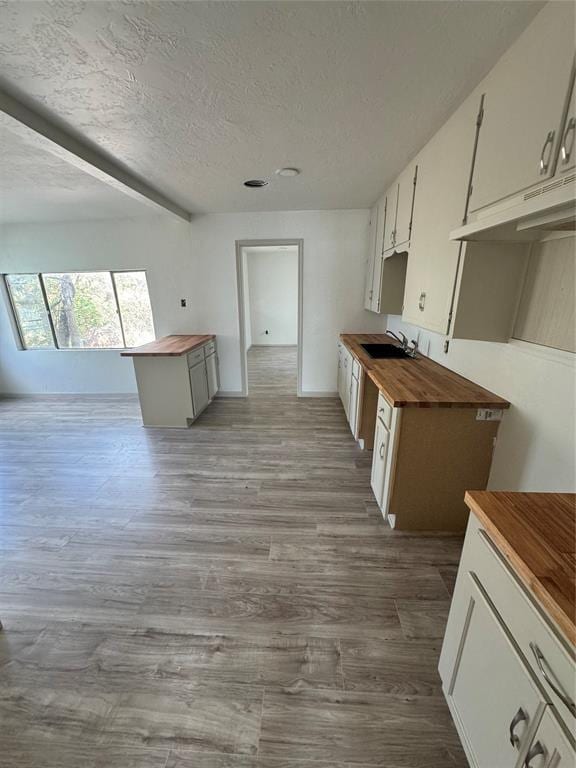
[246,247,298,348]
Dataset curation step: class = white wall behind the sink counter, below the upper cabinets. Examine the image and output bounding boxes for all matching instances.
[388,316,576,493]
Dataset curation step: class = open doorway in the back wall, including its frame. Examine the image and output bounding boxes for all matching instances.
[236,240,303,397]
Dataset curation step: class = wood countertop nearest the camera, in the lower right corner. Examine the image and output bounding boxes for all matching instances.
[465,491,576,644]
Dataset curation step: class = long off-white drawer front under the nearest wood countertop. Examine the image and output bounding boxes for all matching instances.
[463,515,576,728]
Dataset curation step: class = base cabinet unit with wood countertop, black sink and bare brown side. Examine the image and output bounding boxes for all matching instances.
[338,333,510,531]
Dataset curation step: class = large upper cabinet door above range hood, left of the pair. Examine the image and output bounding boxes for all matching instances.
[470,3,575,210]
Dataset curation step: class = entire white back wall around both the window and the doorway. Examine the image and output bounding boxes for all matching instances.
[0,210,382,394]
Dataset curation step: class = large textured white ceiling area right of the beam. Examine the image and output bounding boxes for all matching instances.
[0,0,542,212]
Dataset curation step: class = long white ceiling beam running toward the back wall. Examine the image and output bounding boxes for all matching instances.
[0,90,192,221]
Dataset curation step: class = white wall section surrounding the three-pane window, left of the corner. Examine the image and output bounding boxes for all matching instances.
[0,216,195,394]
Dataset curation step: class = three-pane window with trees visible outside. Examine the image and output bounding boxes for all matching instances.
[4,272,155,349]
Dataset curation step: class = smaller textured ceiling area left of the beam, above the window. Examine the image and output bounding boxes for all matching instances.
[0,128,150,223]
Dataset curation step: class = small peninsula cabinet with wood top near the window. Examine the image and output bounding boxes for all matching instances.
[120,333,219,428]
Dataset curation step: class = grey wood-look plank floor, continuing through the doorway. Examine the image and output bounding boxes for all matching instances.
[0,348,466,768]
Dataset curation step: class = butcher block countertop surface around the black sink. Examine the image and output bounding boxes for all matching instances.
[340,333,510,408]
